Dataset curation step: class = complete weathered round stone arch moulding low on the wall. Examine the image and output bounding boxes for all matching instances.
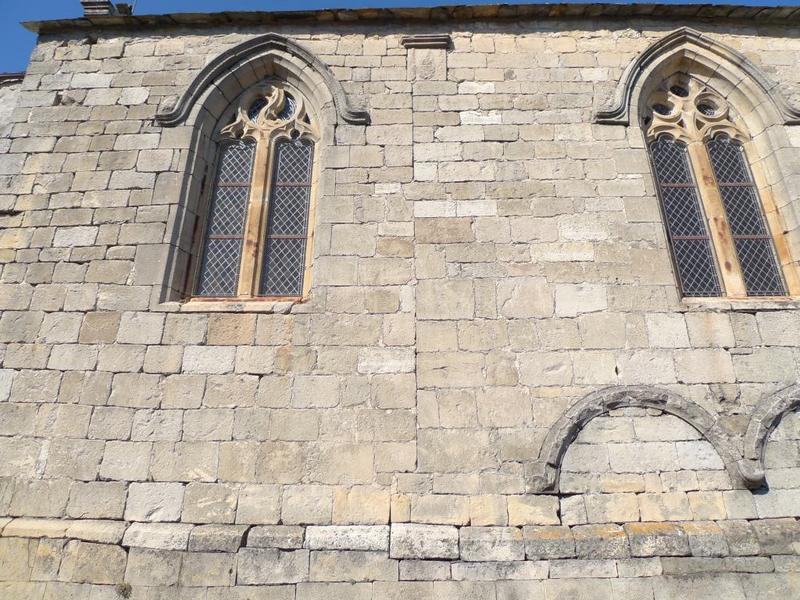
[526,386,750,494]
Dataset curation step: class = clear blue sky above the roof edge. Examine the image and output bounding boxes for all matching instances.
[0,0,800,73]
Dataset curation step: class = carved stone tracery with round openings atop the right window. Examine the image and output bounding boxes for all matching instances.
[645,73,747,144]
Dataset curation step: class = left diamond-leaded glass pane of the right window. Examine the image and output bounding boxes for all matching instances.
[650,137,722,296]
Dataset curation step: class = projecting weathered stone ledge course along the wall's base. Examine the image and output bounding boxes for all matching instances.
[0,518,800,570]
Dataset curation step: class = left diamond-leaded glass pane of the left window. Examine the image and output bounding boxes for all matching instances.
[197,142,255,297]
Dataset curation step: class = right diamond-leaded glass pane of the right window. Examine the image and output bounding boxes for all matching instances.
[706,136,786,296]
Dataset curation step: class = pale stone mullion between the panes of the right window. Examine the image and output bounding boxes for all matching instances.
[688,141,747,298]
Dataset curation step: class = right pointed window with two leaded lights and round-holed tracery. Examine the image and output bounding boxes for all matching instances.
[643,73,798,298]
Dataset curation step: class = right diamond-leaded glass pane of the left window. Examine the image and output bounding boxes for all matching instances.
[261,140,314,296]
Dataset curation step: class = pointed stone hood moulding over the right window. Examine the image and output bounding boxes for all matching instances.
[595,27,800,125]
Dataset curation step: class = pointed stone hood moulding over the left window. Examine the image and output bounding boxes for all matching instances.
[156,33,369,127]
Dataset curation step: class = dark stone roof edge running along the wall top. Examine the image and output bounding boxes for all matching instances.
[23,3,800,34]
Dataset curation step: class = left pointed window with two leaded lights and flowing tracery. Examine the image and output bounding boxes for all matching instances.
[195,84,318,299]
